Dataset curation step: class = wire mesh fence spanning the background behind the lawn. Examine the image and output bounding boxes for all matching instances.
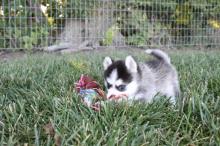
[0,0,220,50]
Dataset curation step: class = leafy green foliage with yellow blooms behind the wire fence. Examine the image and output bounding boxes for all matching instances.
[0,0,220,49]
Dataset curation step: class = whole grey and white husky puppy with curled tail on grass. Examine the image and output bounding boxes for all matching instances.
[103,49,180,104]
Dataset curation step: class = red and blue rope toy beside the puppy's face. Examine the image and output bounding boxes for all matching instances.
[75,75,106,111]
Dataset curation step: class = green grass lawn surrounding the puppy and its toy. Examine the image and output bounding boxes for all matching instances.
[0,51,220,146]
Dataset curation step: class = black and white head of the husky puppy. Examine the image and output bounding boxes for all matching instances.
[103,56,138,98]
